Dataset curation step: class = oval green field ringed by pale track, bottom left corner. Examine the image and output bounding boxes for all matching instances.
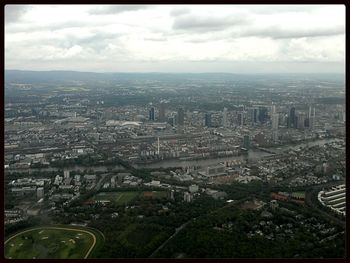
[4,226,97,259]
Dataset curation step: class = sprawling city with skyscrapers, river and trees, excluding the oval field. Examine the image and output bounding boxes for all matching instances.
[4,74,346,258]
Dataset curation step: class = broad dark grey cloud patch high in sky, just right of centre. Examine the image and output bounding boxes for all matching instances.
[173,15,249,31]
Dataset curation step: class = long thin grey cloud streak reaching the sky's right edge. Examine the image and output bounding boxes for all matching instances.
[241,26,345,39]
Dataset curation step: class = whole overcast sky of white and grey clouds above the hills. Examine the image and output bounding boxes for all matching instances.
[5,5,345,73]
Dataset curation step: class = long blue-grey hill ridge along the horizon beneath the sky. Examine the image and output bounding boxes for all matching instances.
[5,70,345,83]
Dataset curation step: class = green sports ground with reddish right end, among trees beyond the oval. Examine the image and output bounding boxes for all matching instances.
[92,191,167,205]
